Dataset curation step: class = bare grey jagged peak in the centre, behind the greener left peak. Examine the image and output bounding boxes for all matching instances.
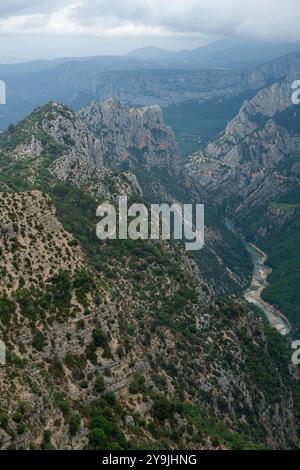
[79,98,180,174]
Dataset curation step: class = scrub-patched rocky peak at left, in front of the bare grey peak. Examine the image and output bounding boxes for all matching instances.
[1,102,142,198]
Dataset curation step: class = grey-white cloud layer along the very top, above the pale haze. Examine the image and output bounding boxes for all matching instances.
[0,0,300,41]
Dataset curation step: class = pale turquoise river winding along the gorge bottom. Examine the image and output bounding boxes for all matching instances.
[226,220,291,335]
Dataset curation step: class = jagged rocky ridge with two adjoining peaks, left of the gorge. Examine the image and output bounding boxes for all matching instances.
[0,99,180,197]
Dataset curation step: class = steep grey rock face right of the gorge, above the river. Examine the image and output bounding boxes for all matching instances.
[186,70,300,216]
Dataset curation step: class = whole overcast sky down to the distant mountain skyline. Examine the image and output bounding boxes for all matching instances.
[0,0,300,62]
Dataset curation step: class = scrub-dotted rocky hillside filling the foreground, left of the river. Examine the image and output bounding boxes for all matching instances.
[0,191,299,449]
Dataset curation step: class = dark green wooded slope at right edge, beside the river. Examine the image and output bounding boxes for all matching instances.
[239,178,300,338]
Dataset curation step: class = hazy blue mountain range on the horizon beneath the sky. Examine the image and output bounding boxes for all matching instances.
[0,39,300,77]
